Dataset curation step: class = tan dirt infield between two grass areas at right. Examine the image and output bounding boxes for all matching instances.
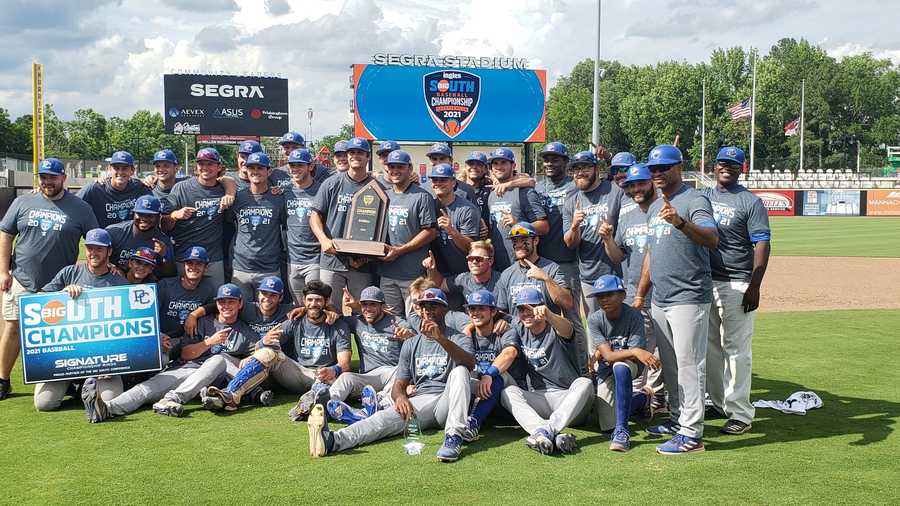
[760,257,900,311]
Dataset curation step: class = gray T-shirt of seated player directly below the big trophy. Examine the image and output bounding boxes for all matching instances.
[344,314,410,374]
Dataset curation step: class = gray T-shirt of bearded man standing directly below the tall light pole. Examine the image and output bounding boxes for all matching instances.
[563,181,624,283]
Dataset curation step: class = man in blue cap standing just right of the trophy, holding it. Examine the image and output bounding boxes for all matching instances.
[380,149,437,315]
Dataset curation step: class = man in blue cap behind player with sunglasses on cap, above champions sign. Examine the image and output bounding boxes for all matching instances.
[106,195,176,277]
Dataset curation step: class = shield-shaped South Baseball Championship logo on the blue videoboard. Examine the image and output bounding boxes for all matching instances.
[424,70,481,139]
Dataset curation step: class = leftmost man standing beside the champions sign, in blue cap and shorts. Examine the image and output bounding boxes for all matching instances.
[0,158,97,400]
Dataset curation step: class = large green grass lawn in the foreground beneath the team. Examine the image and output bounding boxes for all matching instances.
[0,310,900,505]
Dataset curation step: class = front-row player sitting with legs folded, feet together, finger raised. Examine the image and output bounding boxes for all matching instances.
[500,287,593,455]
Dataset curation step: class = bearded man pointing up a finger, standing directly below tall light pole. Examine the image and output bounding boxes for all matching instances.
[563,151,623,314]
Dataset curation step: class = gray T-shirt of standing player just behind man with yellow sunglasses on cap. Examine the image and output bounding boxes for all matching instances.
[488,188,547,271]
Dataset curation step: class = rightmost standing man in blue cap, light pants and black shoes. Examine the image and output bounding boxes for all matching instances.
[703,146,772,434]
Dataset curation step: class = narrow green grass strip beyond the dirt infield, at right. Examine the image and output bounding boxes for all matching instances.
[769,216,900,257]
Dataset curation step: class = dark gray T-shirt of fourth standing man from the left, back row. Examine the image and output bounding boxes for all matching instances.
[166,177,228,262]
